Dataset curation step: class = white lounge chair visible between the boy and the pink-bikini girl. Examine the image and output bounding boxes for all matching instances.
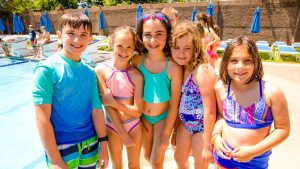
[81,40,111,63]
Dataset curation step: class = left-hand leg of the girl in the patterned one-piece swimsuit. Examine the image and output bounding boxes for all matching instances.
[174,123,192,169]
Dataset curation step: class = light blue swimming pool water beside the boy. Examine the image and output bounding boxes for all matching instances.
[0,58,47,169]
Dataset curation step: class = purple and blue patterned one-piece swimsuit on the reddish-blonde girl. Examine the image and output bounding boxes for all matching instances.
[179,73,204,134]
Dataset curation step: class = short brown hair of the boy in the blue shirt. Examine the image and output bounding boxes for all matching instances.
[60,12,92,35]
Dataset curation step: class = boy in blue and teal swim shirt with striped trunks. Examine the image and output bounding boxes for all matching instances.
[33,13,108,168]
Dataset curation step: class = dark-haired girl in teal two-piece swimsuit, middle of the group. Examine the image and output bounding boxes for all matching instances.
[133,12,182,168]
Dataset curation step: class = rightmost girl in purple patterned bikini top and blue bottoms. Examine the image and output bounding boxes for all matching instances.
[211,37,290,169]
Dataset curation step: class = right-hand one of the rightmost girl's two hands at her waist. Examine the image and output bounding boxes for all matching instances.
[231,146,255,162]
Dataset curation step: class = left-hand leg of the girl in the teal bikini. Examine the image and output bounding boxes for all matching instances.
[141,118,153,161]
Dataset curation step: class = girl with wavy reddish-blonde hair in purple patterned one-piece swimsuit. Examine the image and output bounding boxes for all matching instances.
[170,23,217,169]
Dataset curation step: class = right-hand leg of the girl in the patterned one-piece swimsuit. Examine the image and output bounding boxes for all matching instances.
[192,132,208,169]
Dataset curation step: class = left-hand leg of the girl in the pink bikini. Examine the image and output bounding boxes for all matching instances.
[106,127,123,168]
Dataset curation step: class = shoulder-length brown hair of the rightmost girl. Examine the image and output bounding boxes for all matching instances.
[220,37,264,84]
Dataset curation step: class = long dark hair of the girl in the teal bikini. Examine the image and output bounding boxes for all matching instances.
[136,10,172,56]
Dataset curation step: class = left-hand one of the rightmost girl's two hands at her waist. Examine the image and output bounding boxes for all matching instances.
[214,136,231,160]
